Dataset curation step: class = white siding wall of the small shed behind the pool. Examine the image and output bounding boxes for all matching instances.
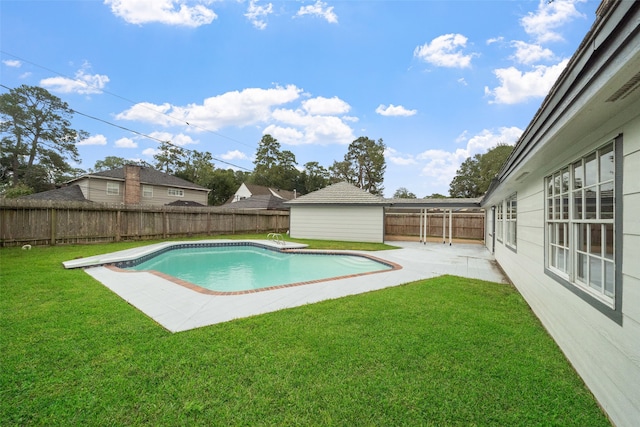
[289,205,384,243]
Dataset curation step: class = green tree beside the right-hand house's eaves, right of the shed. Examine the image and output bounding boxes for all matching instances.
[449,144,513,197]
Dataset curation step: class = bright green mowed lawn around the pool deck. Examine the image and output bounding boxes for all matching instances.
[0,236,610,426]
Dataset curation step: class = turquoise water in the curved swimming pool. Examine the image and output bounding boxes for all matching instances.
[119,246,392,292]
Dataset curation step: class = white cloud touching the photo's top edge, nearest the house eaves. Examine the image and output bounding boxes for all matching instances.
[520,0,586,43]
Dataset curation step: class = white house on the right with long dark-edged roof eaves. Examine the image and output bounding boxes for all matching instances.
[481,0,640,427]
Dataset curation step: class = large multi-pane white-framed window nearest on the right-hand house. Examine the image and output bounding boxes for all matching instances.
[545,138,621,320]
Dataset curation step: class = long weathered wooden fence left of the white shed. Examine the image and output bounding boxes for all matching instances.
[0,199,289,246]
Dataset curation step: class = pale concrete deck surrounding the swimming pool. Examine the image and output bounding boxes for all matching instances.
[69,240,508,332]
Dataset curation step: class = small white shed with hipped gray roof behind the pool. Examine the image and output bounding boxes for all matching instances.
[285,182,386,243]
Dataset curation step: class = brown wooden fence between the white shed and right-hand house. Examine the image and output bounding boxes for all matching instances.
[385,211,484,240]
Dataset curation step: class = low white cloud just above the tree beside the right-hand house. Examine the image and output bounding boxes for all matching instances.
[415,126,523,194]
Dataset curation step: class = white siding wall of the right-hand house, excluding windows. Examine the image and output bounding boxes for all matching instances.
[483,109,640,426]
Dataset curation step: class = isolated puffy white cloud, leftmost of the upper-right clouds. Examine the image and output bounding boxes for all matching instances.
[413,34,476,68]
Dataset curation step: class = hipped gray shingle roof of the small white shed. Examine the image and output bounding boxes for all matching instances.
[285,182,388,206]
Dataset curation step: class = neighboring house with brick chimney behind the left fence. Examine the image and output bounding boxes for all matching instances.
[27,165,210,206]
